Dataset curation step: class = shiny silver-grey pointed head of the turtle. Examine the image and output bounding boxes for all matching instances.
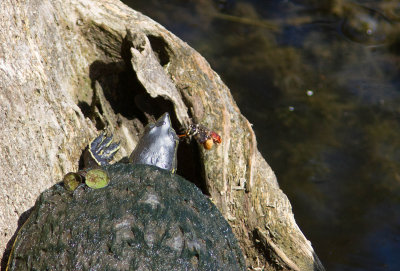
[129,113,178,172]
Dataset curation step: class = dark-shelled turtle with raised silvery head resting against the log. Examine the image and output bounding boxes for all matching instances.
[6,113,246,271]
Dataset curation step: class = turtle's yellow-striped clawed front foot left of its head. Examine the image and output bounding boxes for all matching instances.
[89,132,120,166]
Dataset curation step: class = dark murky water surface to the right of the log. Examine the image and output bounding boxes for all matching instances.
[125,0,400,270]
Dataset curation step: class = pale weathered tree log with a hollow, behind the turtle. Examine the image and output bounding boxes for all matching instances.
[0,0,323,270]
